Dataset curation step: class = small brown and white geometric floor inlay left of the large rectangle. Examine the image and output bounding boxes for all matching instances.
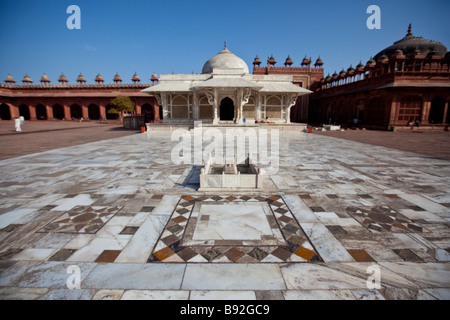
[38,206,122,233]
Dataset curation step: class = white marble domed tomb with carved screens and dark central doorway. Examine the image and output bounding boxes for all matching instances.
[142,42,311,125]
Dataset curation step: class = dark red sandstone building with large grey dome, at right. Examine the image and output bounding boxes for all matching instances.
[309,25,450,130]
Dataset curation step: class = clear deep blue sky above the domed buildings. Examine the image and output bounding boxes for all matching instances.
[0,0,450,83]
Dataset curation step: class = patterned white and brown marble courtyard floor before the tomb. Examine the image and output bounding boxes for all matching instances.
[0,128,450,300]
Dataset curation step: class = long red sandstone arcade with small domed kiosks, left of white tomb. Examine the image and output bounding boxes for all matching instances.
[0,74,159,121]
